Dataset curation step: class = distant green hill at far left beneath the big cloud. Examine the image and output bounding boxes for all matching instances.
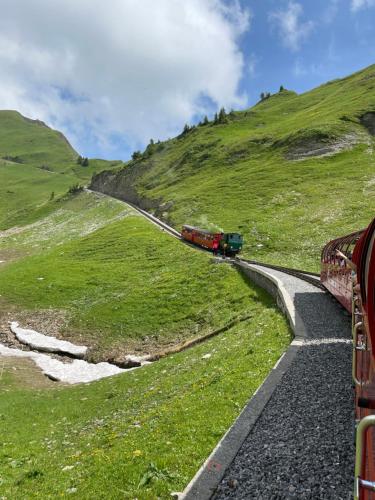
[0,111,120,230]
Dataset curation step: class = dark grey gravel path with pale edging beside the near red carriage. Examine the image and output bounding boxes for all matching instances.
[214,269,354,500]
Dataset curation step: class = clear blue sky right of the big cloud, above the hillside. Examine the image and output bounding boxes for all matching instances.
[236,0,375,104]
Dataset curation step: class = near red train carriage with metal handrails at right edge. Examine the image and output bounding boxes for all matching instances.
[321,219,375,500]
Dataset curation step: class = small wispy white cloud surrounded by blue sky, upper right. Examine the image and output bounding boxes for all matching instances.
[269,1,314,51]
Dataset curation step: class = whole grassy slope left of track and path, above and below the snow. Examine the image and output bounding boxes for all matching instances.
[0,193,290,499]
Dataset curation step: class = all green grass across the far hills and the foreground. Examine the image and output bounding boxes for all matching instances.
[0,60,375,499]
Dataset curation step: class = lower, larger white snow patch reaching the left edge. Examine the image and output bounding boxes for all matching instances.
[0,344,125,384]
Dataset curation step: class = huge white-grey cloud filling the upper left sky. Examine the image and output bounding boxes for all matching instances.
[0,0,250,153]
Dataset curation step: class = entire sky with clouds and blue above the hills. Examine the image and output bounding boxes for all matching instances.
[0,0,375,160]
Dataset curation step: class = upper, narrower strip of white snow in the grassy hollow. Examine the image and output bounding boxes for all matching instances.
[10,321,87,358]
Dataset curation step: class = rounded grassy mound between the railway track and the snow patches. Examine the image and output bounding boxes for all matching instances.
[0,193,268,359]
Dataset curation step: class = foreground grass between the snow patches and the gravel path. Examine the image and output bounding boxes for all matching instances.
[0,287,289,500]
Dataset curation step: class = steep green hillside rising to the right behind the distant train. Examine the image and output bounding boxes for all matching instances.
[92,66,375,269]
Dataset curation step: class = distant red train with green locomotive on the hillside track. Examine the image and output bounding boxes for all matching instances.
[181,225,243,256]
